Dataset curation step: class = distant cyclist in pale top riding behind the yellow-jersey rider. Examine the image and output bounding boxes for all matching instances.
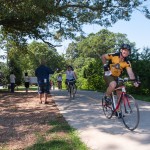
[65,65,77,87]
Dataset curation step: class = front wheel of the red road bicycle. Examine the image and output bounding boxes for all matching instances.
[121,94,140,131]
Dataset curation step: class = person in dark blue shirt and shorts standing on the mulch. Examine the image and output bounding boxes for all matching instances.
[35,60,54,104]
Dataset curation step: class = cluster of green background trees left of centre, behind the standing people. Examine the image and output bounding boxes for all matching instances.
[0,41,66,85]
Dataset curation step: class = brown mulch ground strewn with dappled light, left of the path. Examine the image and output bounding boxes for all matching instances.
[0,92,65,150]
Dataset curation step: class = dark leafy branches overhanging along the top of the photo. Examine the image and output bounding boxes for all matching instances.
[0,0,150,46]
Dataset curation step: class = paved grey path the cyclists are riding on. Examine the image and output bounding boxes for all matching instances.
[51,90,150,150]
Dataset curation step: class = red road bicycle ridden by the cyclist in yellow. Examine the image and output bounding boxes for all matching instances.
[102,78,140,131]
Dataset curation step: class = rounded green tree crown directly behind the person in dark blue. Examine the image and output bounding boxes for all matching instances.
[21,41,65,75]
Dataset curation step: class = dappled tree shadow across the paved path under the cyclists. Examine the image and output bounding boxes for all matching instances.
[53,91,150,145]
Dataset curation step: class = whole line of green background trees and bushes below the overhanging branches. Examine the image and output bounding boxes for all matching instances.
[1,29,150,95]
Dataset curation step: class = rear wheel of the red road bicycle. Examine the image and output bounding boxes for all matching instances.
[102,97,113,119]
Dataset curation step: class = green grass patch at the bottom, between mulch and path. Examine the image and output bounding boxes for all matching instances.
[25,120,89,150]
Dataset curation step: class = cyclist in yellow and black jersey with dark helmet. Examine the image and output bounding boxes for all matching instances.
[101,44,139,112]
